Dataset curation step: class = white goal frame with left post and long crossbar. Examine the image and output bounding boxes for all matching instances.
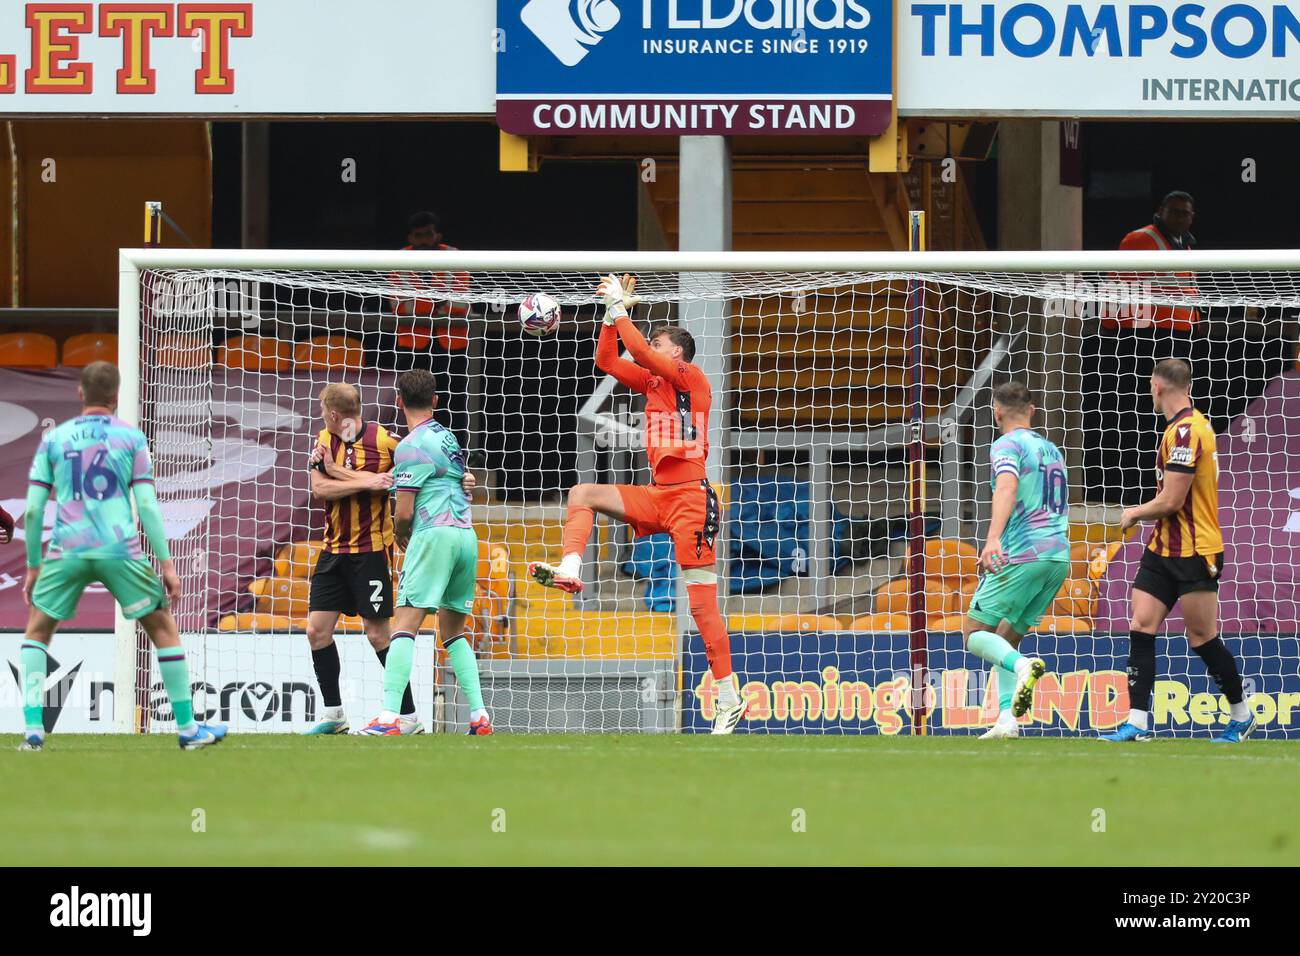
[113,248,1300,732]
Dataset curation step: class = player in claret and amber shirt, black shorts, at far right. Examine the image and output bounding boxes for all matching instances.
[1102,359,1255,744]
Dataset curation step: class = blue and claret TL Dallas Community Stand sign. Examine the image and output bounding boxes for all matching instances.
[497,0,893,135]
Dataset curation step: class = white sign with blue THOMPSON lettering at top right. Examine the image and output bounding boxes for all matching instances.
[898,0,1300,118]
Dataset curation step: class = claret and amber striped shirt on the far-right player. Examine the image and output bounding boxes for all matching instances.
[1147,407,1223,558]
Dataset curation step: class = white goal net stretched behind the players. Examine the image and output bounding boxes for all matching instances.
[117,251,1300,736]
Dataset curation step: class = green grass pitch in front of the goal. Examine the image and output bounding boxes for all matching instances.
[0,734,1300,866]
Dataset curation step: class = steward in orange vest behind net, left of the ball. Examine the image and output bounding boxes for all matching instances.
[378,212,469,447]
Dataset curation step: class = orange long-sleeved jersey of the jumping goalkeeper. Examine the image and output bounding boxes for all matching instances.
[595,317,714,485]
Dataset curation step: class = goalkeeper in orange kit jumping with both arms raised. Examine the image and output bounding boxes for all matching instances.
[528,276,745,734]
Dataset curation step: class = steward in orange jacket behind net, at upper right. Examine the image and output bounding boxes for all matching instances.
[1082,191,1204,505]
